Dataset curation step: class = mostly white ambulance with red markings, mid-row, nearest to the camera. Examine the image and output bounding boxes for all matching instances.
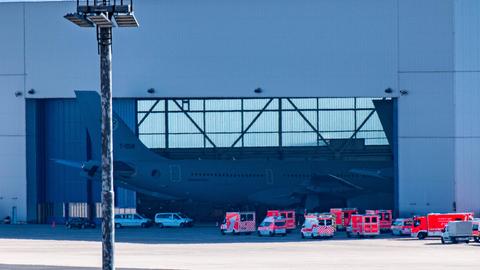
[300,214,336,238]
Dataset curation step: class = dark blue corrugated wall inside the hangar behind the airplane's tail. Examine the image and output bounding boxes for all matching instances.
[27,99,136,222]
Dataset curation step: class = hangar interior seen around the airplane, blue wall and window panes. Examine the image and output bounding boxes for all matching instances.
[27,97,394,223]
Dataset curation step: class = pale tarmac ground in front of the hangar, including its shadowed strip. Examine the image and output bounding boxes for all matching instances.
[0,225,480,270]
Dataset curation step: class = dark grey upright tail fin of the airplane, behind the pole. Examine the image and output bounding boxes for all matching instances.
[75,91,165,161]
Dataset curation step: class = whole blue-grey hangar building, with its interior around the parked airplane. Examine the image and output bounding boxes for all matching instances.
[0,0,480,223]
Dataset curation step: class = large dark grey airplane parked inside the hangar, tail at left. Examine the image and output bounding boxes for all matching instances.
[55,91,393,212]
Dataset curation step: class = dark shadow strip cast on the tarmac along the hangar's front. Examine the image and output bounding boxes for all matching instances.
[0,225,412,244]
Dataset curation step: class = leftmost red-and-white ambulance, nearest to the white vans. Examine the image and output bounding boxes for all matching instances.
[220,212,256,234]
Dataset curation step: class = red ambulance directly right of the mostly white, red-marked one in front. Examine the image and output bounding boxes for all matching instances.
[347,214,380,238]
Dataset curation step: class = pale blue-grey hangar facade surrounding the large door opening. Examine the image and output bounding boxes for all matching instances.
[0,0,480,221]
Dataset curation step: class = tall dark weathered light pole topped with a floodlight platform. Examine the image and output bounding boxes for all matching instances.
[64,0,138,270]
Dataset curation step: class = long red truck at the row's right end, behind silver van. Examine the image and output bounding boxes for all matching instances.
[411,213,473,239]
